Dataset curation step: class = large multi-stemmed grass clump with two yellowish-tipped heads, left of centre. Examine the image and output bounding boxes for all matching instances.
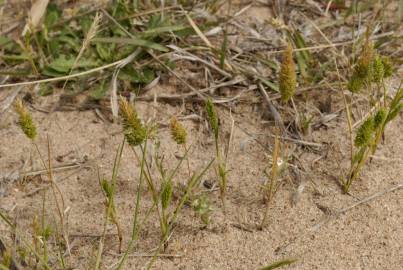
[117,100,214,269]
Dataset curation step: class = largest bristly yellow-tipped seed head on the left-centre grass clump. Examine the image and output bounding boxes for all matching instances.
[120,99,147,146]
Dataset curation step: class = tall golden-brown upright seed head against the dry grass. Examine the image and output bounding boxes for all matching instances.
[279,45,297,102]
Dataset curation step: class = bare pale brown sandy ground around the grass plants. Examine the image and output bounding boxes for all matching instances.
[0,0,403,270]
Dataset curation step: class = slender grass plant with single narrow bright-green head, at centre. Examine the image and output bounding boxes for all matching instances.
[206,99,227,213]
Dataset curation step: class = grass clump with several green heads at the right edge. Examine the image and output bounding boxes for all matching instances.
[341,37,403,193]
